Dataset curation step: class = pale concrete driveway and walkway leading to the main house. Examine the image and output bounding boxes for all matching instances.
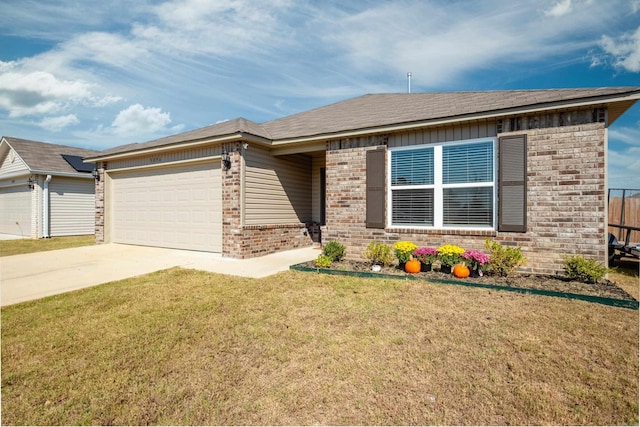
[0,243,320,306]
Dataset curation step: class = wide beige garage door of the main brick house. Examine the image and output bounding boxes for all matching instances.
[110,162,222,252]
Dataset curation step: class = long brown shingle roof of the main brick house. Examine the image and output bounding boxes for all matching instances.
[86,87,640,157]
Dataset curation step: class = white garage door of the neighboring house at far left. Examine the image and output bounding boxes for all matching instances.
[0,184,33,237]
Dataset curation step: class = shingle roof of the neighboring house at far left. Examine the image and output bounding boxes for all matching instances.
[4,136,100,174]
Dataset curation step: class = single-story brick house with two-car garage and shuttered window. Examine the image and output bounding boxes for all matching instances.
[85,87,640,273]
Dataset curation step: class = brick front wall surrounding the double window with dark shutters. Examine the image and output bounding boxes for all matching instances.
[323,123,607,274]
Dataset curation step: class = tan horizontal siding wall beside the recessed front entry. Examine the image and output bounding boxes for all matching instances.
[244,146,312,225]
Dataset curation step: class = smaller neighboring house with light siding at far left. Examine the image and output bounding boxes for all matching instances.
[0,137,97,238]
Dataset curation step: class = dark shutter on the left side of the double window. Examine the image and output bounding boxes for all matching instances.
[366,149,386,228]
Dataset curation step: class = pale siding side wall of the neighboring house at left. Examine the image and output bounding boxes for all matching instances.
[49,176,95,237]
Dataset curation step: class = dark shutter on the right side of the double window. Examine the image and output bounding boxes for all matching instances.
[498,135,527,233]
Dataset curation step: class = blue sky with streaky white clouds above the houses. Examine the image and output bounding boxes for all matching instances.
[0,0,640,188]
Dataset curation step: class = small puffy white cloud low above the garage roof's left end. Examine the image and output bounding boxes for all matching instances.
[111,104,171,137]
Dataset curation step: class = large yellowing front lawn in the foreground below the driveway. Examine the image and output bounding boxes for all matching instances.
[2,268,638,425]
